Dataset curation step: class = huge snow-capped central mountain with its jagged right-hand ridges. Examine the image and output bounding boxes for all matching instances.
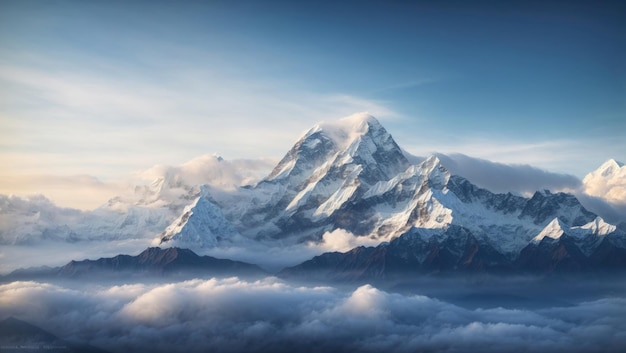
[160,114,622,271]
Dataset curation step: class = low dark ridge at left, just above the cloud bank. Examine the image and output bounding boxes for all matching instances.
[4,247,267,281]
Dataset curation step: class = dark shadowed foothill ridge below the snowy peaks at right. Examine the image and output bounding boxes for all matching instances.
[278,226,626,282]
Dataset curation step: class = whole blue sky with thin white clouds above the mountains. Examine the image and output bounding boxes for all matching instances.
[0,0,626,204]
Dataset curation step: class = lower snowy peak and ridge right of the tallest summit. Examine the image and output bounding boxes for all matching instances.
[357,156,595,257]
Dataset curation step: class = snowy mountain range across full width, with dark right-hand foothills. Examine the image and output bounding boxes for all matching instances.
[0,114,626,278]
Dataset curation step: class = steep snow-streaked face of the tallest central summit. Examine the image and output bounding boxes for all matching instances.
[220,114,409,238]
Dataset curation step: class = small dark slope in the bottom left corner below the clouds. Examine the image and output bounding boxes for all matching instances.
[0,317,106,353]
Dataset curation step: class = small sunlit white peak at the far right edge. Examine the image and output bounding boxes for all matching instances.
[583,159,626,205]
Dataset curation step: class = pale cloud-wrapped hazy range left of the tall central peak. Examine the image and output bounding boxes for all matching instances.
[0,155,271,245]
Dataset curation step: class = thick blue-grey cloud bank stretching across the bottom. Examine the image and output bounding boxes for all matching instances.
[0,278,626,352]
